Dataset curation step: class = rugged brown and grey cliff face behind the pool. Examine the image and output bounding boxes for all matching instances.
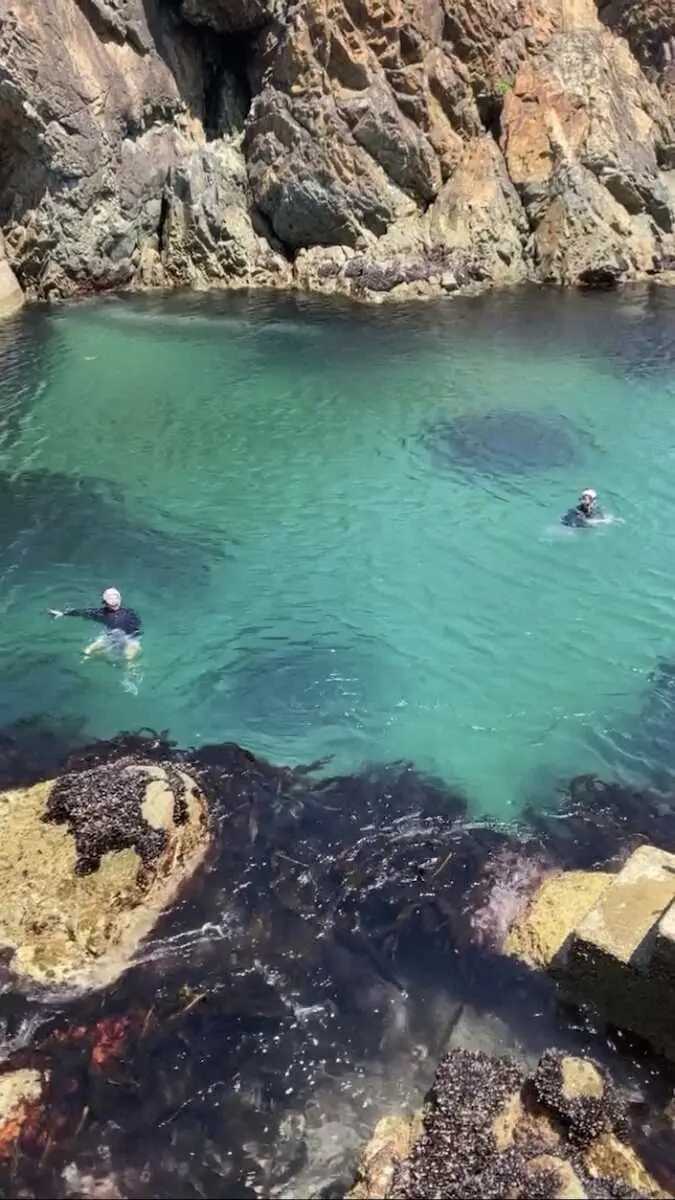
[0,0,675,298]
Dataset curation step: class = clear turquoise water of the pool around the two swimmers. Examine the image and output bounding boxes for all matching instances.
[0,289,675,818]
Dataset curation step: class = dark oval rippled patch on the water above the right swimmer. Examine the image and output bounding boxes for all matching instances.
[424,409,580,475]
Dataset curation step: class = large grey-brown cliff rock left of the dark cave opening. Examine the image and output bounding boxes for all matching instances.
[0,0,203,295]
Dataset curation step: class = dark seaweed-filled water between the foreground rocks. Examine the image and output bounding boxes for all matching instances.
[0,686,675,1198]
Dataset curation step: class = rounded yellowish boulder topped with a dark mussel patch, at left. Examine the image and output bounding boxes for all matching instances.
[0,757,208,988]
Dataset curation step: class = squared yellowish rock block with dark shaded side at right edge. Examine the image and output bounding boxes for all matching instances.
[506,846,675,1058]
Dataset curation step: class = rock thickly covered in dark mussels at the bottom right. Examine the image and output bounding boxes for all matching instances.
[350,1050,665,1200]
